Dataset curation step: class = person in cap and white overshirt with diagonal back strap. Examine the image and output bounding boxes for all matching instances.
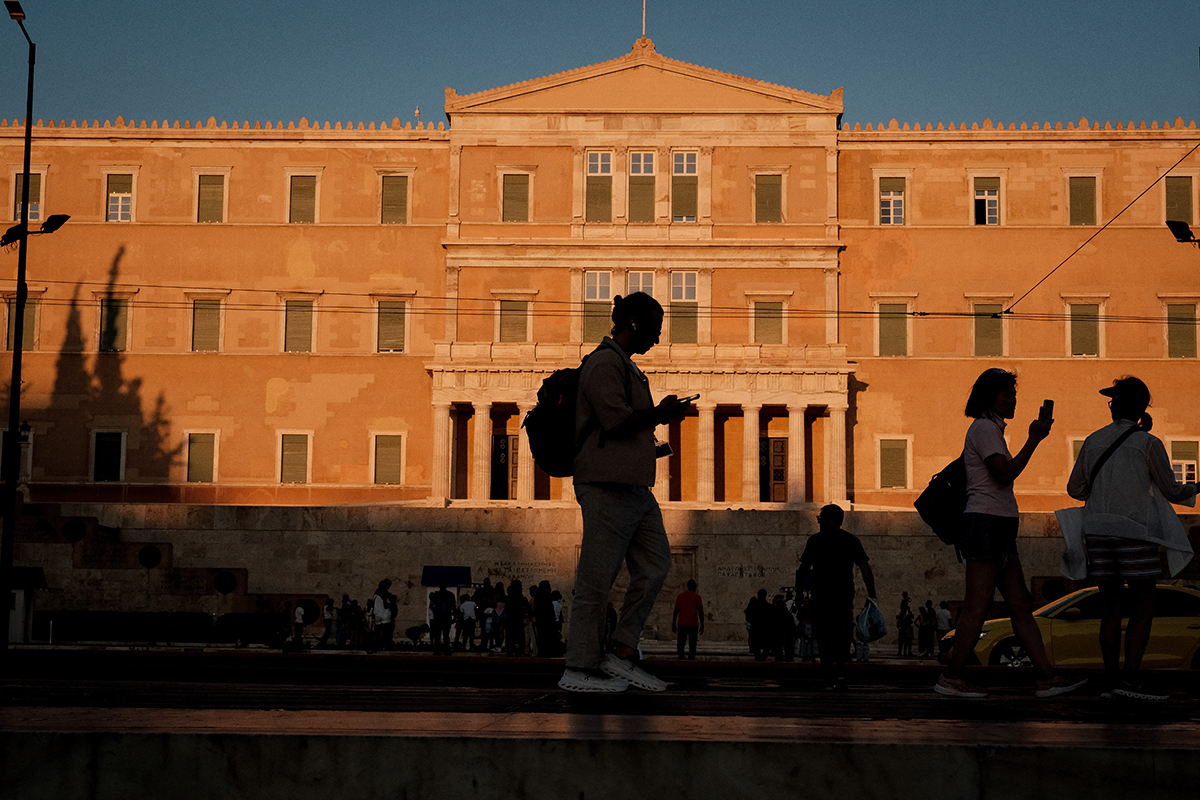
[1063,377,1196,700]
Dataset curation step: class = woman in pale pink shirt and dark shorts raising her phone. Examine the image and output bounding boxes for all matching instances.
[934,367,1087,698]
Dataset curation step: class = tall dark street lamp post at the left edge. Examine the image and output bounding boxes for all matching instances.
[0,0,45,662]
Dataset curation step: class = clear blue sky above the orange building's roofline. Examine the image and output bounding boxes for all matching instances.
[0,0,1200,124]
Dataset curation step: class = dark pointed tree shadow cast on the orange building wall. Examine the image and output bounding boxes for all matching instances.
[3,246,184,485]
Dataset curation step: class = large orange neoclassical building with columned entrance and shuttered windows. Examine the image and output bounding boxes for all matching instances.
[0,38,1200,623]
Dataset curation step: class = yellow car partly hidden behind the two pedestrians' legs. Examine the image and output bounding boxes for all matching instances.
[946,583,1200,669]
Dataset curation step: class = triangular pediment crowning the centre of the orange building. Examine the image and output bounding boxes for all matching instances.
[445,38,842,116]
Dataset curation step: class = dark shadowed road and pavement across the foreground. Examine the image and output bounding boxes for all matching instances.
[0,649,1200,800]
